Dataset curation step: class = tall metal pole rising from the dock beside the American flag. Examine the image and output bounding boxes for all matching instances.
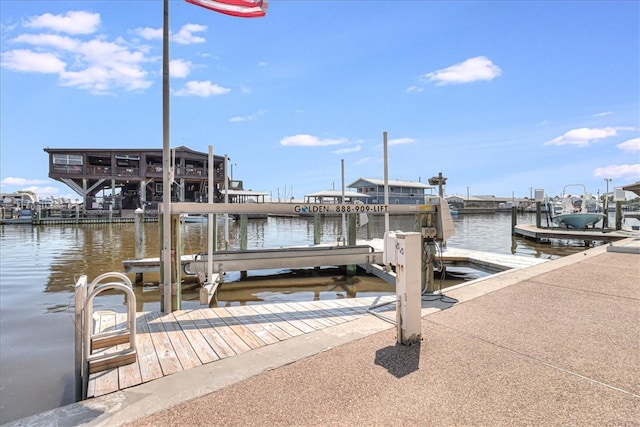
[161,0,173,313]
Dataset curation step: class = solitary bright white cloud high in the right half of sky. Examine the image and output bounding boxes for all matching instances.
[422,56,502,86]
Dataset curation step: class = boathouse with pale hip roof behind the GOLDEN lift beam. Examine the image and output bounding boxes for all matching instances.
[348,178,434,205]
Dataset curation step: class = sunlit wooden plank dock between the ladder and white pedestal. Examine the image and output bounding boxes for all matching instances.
[87,294,396,398]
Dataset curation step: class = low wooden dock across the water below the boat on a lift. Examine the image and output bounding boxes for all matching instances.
[513,224,638,242]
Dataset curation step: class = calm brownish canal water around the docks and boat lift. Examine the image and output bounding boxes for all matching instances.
[0,214,600,424]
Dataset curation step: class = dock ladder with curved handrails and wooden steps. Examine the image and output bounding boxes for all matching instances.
[75,272,137,401]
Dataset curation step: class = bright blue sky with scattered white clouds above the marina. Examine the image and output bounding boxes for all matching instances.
[0,0,640,199]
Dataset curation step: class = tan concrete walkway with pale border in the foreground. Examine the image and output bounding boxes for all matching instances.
[6,239,640,426]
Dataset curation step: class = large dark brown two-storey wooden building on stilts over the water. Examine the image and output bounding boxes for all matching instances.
[44,147,229,210]
